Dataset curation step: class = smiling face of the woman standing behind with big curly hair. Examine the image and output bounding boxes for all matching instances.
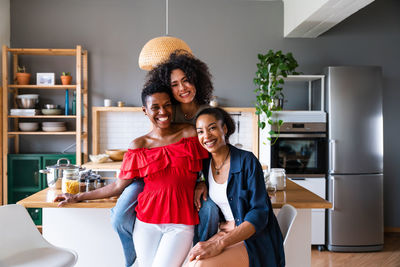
[171,69,196,104]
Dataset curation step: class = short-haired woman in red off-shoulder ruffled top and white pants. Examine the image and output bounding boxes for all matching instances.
[55,83,208,267]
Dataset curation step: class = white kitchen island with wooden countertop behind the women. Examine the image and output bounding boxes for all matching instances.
[17,180,332,267]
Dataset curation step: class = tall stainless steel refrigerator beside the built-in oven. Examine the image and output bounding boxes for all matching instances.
[324,66,383,251]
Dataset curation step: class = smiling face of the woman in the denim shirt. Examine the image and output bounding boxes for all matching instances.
[196,114,228,153]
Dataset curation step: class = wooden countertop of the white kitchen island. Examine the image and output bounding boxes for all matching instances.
[17,180,332,209]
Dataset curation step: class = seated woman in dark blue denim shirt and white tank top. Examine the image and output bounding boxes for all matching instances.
[189,108,285,267]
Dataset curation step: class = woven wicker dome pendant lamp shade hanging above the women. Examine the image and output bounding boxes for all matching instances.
[139,36,192,71]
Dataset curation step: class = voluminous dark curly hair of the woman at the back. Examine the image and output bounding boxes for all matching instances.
[146,50,214,105]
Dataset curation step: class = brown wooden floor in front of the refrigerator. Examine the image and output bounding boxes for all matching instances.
[311,233,400,267]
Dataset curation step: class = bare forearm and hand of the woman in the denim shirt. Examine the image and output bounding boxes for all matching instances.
[189,222,256,261]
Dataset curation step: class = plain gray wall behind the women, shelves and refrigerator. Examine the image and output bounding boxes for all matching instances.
[11,0,400,227]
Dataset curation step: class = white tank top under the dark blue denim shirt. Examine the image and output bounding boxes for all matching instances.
[208,161,235,222]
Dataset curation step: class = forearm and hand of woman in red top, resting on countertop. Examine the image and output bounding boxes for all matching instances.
[53,179,133,207]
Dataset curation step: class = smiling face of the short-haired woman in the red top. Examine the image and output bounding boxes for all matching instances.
[142,93,172,128]
